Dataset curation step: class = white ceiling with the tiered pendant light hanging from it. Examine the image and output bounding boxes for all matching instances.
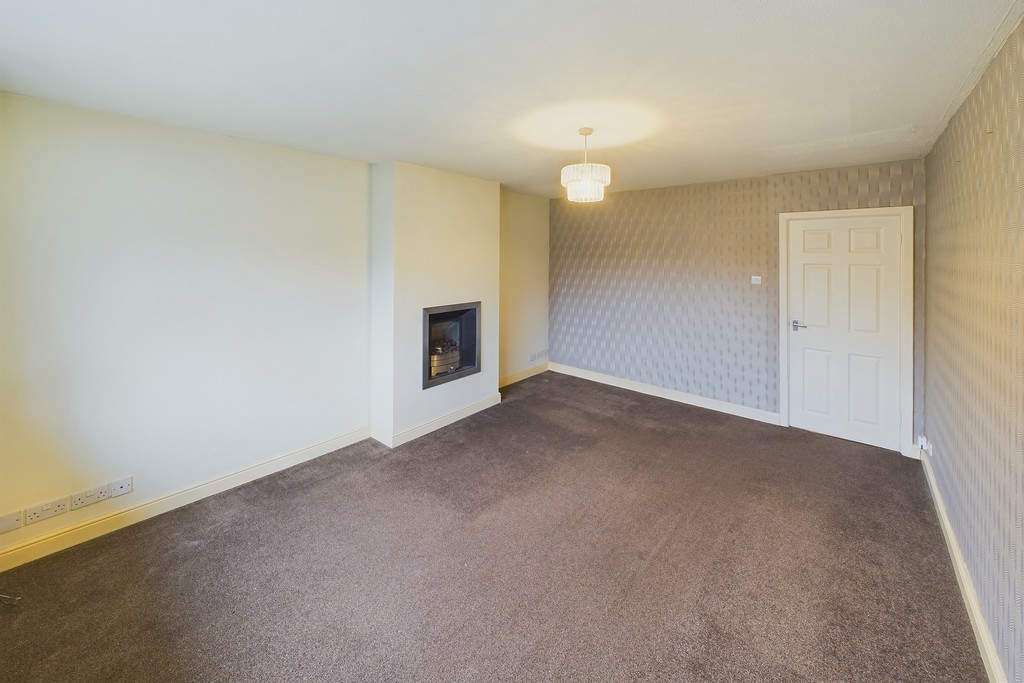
[0,0,1024,197]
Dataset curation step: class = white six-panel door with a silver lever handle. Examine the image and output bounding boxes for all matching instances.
[780,207,913,452]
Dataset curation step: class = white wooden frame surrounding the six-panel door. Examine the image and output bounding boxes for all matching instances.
[778,206,914,458]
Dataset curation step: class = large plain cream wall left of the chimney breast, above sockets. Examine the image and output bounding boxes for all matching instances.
[0,95,370,551]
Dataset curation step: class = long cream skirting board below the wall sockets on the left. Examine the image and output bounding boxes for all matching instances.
[0,427,370,571]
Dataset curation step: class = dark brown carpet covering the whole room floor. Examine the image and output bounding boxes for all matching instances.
[0,373,985,682]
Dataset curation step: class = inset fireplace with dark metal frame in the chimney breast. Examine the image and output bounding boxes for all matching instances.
[423,301,480,389]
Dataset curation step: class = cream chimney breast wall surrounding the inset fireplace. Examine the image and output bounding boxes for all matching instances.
[372,162,500,445]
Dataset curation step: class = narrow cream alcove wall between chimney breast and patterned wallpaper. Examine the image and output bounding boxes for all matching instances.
[498,190,551,385]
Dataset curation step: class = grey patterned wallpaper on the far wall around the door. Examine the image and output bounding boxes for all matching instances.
[549,160,925,421]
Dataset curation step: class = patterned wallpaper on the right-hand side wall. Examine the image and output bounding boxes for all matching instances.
[925,18,1024,683]
